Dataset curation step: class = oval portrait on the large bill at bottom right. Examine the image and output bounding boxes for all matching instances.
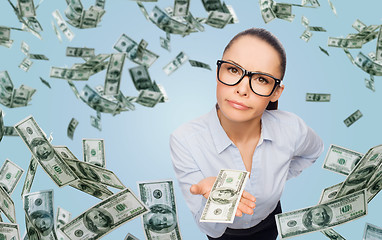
[302,205,333,229]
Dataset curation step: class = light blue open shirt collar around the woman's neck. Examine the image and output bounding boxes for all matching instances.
[208,104,273,154]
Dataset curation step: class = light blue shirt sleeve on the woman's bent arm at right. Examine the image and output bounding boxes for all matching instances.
[287,117,324,180]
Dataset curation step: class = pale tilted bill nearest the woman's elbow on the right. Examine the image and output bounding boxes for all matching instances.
[322,144,363,175]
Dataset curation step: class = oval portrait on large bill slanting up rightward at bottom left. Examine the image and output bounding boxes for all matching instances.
[83,208,114,234]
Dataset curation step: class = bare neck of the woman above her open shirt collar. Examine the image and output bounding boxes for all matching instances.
[217,109,261,145]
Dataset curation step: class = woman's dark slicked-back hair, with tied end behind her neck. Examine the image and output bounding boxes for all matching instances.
[223,28,286,110]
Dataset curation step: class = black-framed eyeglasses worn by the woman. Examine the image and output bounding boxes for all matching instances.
[216,60,282,97]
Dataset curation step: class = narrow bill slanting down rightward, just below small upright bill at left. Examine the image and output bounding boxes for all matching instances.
[64,158,125,189]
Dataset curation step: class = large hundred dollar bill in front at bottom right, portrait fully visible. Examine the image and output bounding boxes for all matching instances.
[275,190,367,239]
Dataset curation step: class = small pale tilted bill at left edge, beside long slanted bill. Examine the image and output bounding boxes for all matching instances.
[0,159,24,195]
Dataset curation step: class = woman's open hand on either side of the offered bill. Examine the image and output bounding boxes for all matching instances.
[190,177,256,217]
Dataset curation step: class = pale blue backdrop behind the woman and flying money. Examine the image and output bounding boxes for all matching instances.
[0,0,382,240]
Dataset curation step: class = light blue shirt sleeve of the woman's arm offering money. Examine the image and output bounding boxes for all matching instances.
[170,134,227,238]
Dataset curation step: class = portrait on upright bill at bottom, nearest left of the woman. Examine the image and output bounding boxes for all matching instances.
[143,204,177,233]
